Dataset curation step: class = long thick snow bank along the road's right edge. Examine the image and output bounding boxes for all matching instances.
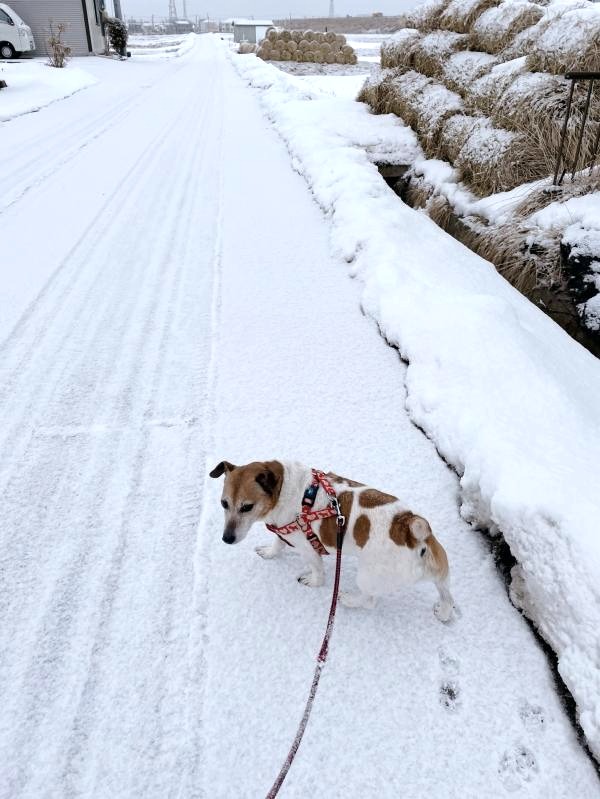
[233,51,600,756]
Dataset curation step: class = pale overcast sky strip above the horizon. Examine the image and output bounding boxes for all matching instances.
[119,0,419,19]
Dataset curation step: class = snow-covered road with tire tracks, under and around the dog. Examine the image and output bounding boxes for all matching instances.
[0,37,600,799]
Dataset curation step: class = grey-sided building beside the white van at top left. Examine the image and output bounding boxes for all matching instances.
[9,0,105,55]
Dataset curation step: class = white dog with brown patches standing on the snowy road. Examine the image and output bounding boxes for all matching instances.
[210,461,454,622]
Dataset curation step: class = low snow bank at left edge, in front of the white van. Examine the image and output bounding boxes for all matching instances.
[0,61,97,122]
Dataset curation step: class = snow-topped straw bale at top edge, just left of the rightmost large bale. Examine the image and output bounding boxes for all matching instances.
[470,2,544,54]
